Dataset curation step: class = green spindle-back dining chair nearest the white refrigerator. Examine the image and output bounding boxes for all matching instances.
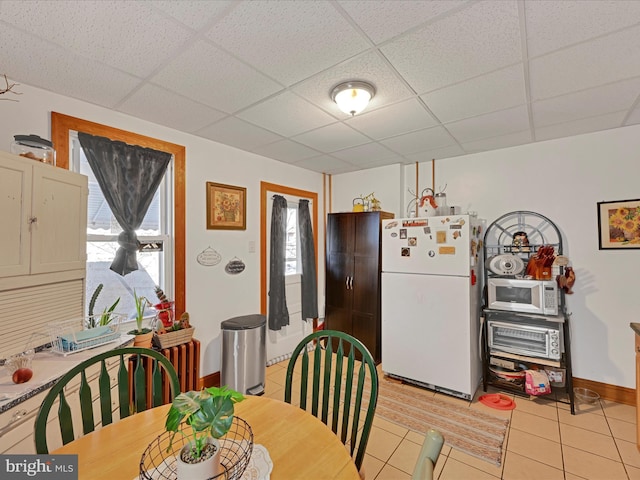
[284,330,378,470]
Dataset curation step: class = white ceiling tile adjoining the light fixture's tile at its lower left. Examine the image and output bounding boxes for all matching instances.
[238,91,336,137]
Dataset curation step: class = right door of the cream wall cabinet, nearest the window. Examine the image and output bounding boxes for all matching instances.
[31,165,88,274]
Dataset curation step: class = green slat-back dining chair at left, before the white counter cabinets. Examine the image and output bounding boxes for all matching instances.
[34,347,180,453]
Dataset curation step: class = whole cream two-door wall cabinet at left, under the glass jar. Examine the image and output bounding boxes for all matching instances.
[0,152,88,282]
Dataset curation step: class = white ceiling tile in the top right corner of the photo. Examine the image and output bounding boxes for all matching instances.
[524,0,640,57]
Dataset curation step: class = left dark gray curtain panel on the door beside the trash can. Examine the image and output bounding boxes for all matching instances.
[269,195,289,330]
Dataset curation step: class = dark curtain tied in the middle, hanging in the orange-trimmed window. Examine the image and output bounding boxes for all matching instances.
[78,132,171,276]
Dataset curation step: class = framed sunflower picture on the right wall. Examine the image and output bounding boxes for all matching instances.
[598,199,640,250]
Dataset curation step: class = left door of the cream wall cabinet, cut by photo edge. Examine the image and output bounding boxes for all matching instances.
[0,156,32,277]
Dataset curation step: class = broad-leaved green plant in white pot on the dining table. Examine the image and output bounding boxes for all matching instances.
[165,386,244,480]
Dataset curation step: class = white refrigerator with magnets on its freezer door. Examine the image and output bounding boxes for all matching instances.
[381,215,483,399]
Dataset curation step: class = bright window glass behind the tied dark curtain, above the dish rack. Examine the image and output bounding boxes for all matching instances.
[71,138,173,317]
